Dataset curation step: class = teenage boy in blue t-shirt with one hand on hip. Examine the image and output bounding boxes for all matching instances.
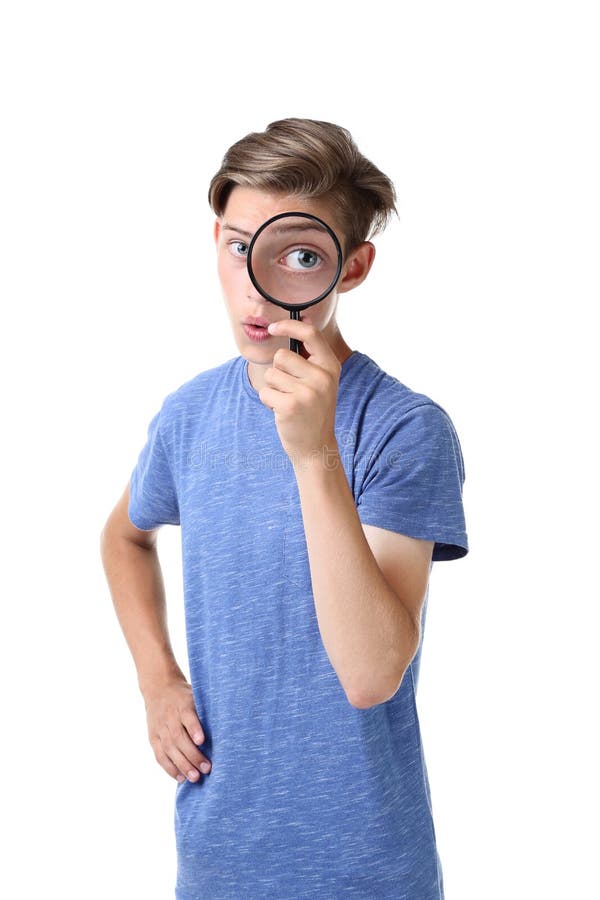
[102,118,468,900]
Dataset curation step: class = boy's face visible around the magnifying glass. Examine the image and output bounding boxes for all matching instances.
[215,185,354,365]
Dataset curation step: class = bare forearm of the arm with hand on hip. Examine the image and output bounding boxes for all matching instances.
[101,532,185,694]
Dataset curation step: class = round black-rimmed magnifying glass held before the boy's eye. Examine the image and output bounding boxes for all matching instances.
[247,212,342,353]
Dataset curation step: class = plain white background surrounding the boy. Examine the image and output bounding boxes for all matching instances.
[0,0,600,900]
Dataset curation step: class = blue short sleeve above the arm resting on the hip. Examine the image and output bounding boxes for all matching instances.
[128,404,179,531]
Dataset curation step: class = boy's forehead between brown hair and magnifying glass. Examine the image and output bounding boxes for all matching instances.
[222,185,341,237]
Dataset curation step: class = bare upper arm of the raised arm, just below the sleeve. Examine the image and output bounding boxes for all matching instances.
[362,523,434,643]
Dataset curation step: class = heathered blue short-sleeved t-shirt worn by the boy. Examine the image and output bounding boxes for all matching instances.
[129,351,468,900]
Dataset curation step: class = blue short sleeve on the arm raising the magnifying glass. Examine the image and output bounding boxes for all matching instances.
[356,402,469,561]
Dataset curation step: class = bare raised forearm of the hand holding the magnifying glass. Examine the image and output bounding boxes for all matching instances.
[294,441,418,706]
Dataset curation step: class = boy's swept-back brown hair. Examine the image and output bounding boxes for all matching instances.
[208,118,398,255]
